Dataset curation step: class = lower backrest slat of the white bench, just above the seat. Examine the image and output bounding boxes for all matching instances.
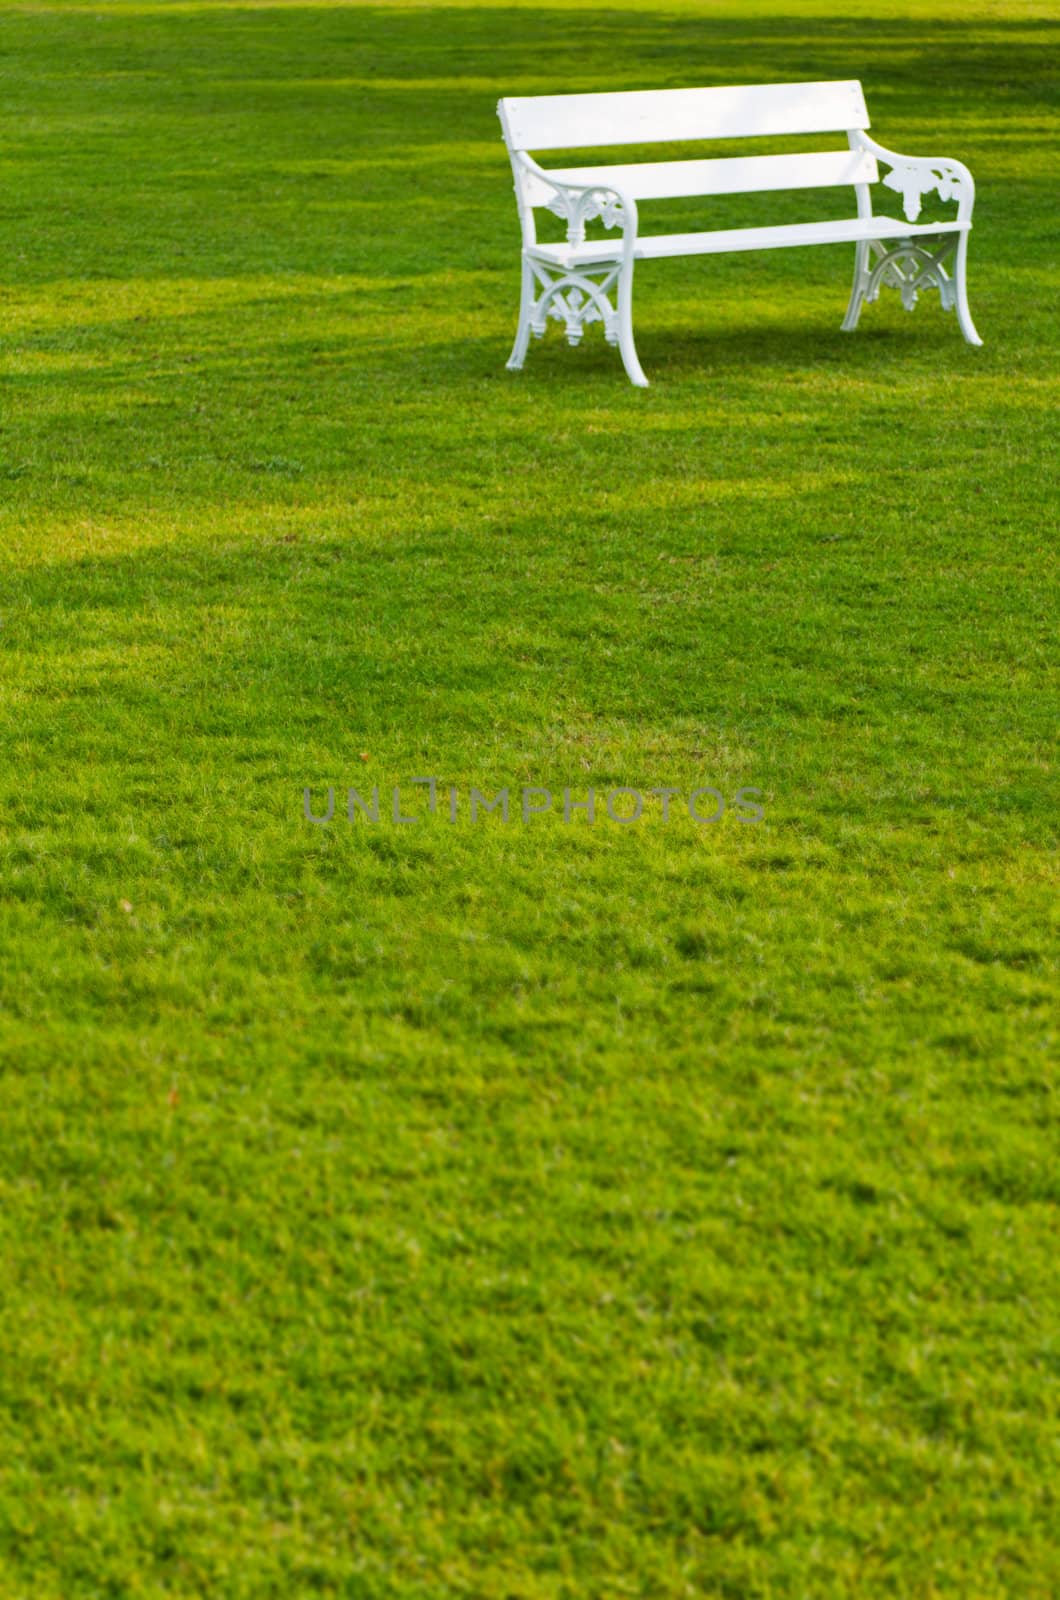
[525,150,879,205]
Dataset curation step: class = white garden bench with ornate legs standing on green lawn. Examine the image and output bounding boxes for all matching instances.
[498,80,983,387]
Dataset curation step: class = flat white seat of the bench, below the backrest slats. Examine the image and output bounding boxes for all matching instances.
[527,216,972,269]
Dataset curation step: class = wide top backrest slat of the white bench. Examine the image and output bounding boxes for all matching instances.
[498,78,869,150]
